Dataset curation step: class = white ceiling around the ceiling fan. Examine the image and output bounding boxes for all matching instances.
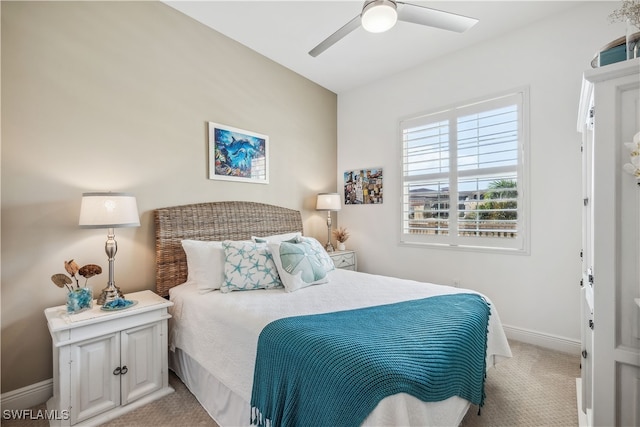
[165,0,579,93]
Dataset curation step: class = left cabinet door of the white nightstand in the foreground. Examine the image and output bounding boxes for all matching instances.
[69,333,120,424]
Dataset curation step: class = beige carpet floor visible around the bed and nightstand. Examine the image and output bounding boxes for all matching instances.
[1,341,580,427]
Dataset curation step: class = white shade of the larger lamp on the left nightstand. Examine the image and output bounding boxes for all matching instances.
[79,193,140,228]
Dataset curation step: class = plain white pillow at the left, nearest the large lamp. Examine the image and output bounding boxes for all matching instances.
[182,240,224,293]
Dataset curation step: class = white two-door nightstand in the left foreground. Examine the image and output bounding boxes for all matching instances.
[44,291,173,426]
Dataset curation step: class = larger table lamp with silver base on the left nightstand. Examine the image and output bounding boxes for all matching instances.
[79,193,140,305]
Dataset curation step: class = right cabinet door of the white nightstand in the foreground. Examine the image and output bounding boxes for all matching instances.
[120,323,165,405]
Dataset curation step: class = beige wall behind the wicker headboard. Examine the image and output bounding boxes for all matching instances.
[1,1,337,392]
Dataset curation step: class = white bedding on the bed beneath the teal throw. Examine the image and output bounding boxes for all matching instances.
[169,270,511,426]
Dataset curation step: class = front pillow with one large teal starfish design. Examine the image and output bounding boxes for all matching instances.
[269,240,328,292]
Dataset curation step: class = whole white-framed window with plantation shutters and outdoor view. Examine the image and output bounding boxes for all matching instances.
[400,90,528,250]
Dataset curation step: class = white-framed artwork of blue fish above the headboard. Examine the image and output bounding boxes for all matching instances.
[209,122,269,184]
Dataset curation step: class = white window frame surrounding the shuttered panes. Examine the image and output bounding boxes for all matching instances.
[398,87,530,254]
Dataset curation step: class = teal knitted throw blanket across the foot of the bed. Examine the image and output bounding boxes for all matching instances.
[251,294,490,427]
